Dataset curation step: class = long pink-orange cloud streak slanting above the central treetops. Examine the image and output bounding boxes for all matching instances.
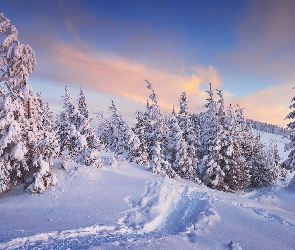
[36,42,221,115]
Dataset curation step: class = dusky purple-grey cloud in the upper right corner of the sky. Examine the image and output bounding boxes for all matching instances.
[222,0,295,81]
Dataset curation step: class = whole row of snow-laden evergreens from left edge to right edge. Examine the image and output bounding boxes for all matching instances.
[0,14,286,193]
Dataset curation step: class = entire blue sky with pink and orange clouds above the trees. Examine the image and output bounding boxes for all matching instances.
[1,0,295,126]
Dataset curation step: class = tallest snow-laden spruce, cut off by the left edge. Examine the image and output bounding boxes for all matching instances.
[0,13,56,193]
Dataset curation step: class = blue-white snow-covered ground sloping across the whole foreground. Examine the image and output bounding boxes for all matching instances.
[0,134,295,250]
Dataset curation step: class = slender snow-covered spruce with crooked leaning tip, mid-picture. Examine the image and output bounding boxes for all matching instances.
[145,80,177,178]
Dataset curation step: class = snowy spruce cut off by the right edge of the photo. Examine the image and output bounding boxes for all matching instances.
[284,88,295,170]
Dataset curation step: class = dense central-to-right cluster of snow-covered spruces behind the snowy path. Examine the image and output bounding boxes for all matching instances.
[98,80,282,191]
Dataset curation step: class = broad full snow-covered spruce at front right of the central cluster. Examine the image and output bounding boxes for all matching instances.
[201,90,250,191]
